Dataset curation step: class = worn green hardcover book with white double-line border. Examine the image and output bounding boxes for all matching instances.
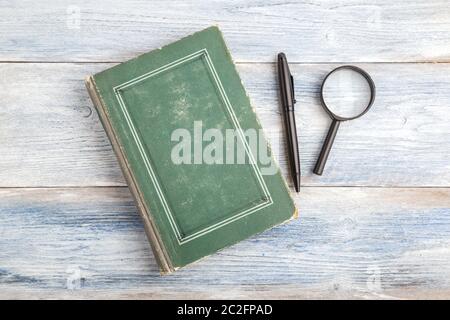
[86,27,297,274]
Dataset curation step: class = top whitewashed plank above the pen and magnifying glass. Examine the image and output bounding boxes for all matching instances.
[0,0,450,62]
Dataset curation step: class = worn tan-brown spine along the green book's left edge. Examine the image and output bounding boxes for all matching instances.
[85,76,174,274]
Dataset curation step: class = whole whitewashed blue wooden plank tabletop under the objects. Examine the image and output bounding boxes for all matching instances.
[0,0,450,299]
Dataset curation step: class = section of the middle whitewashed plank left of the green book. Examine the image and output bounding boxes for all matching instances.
[0,64,124,186]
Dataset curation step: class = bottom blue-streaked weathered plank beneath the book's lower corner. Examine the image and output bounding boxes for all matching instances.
[0,187,450,298]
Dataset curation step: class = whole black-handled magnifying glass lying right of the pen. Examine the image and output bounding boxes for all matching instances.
[313,66,375,175]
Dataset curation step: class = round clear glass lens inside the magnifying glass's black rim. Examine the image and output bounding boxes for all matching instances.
[322,68,371,118]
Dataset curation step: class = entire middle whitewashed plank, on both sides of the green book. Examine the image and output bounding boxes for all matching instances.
[0,63,450,187]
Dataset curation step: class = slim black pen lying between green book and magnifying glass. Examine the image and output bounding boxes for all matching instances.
[278,52,300,192]
